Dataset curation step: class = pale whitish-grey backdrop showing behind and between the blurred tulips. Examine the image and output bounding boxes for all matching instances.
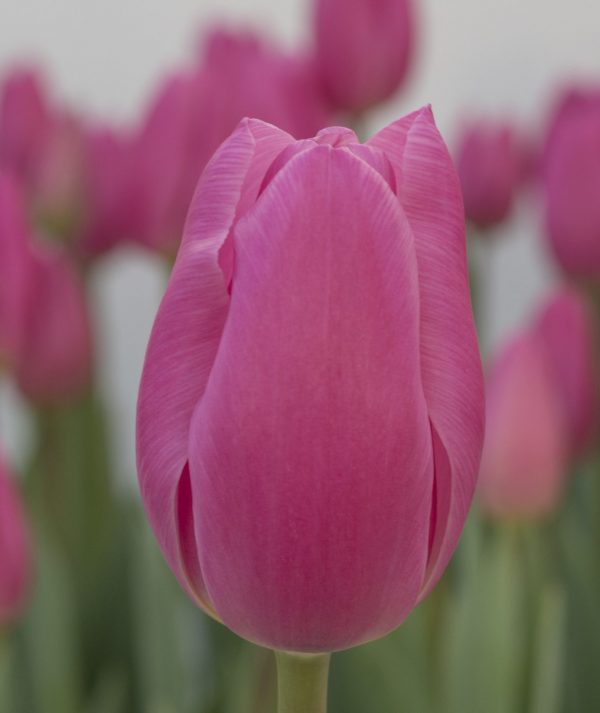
[0,0,600,482]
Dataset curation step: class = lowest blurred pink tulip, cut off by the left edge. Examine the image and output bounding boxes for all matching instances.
[0,448,31,631]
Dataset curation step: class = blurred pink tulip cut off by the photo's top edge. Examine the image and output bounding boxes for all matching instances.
[315,0,414,113]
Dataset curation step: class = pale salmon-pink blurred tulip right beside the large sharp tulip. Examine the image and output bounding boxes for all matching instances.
[479,331,568,518]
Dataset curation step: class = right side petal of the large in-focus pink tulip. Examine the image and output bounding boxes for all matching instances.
[368,108,484,595]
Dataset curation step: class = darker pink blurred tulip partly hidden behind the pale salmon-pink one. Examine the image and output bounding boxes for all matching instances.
[537,287,598,455]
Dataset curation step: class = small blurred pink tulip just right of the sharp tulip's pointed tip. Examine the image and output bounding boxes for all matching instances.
[457,121,524,228]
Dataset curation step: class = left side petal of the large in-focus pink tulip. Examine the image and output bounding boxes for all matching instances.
[137,120,291,608]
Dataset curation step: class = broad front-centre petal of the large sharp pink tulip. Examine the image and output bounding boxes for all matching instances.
[190,146,432,651]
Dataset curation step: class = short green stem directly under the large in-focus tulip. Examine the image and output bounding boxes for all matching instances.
[275,651,331,713]
